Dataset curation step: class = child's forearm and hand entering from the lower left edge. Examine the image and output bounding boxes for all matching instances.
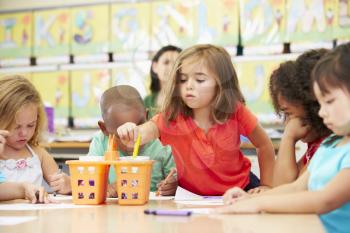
[0,182,50,204]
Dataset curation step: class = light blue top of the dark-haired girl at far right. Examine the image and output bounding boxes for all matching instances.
[308,135,350,233]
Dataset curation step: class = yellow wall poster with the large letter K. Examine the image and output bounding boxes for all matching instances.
[34,8,71,57]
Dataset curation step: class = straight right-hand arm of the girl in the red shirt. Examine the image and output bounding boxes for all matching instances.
[248,124,275,186]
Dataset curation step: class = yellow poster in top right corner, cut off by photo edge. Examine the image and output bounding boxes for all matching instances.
[334,0,350,40]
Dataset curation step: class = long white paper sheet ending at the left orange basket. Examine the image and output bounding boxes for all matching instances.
[0,203,93,210]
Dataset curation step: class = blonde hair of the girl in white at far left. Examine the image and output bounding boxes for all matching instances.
[0,75,46,146]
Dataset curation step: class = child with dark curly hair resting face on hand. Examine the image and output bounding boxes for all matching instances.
[270,49,330,186]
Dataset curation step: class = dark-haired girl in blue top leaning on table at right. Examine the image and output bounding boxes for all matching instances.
[218,43,350,233]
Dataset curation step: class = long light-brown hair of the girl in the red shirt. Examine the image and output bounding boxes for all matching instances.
[162,44,245,123]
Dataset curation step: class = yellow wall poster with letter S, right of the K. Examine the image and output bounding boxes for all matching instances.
[71,5,109,55]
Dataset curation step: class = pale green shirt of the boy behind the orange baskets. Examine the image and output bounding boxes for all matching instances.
[88,131,175,191]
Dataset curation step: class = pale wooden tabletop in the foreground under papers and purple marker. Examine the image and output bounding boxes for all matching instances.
[0,200,324,233]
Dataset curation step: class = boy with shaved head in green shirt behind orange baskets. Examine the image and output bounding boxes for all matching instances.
[88,85,177,197]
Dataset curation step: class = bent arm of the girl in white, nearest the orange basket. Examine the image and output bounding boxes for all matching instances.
[35,147,72,194]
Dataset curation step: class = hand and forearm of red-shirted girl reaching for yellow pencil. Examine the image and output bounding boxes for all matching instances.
[117,121,159,145]
